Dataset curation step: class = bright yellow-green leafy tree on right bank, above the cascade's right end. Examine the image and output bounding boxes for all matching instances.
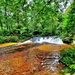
[62,1,75,42]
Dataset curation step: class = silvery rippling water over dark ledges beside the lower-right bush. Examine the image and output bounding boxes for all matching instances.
[41,51,60,71]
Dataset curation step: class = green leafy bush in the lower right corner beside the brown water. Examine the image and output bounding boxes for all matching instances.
[60,48,75,75]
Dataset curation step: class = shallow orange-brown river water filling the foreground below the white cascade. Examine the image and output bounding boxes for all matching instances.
[0,43,71,75]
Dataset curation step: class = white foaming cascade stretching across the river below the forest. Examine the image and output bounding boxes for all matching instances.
[20,36,63,45]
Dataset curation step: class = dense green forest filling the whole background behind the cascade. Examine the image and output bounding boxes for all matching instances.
[0,0,75,41]
